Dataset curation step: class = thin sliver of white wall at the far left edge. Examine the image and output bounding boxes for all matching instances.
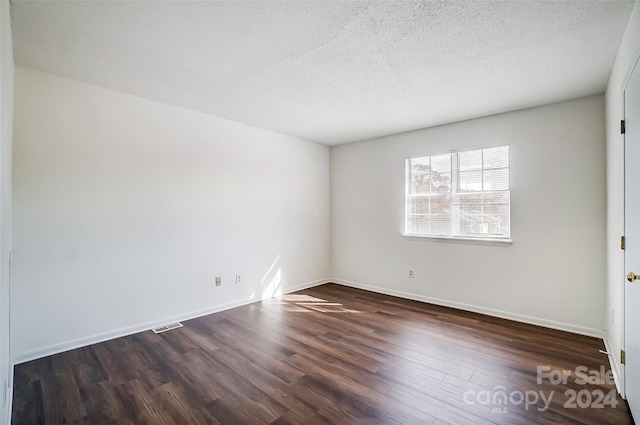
[0,1,13,424]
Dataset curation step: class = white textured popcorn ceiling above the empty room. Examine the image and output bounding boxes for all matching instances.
[12,0,634,145]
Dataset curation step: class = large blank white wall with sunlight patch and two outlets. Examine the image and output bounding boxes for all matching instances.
[12,67,330,361]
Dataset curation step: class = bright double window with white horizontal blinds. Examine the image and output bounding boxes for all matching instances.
[405,145,511,241]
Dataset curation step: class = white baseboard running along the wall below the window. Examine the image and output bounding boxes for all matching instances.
[332,279,605,339]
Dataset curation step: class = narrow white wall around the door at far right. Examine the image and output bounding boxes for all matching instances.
[605,3,640,390]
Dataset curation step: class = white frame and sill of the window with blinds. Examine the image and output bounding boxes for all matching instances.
[402,143,513,245]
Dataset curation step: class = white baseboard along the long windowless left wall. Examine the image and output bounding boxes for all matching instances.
[13,279,331,365]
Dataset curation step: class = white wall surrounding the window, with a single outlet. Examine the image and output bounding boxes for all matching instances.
[331,95,605,335]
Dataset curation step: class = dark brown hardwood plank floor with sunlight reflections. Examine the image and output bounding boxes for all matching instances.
[12,284,632,425]
